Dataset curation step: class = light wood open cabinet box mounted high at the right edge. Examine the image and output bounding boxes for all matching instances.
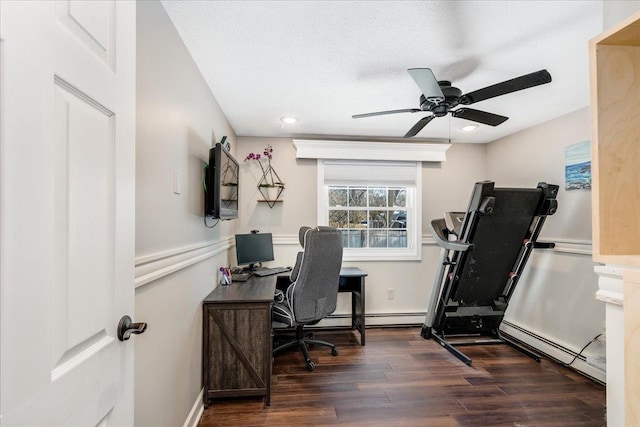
[589,13,640,266]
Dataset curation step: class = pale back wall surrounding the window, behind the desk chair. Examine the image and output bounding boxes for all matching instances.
[238,137,485,325]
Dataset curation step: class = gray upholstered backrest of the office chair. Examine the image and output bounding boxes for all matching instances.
[288,226,342,323]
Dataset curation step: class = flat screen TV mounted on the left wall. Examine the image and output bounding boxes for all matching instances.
[204,143,240,220]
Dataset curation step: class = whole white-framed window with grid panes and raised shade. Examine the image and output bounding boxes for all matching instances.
[318,160,422,261]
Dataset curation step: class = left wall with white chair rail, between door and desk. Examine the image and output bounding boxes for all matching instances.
[133,1,236,427]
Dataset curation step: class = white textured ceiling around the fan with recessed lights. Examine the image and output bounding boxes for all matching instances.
[162,0,603,143]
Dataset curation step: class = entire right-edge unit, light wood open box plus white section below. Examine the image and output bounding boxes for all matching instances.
[589,13,640,426]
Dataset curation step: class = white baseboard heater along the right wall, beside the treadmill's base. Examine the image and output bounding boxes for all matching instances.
[500,320,606,384]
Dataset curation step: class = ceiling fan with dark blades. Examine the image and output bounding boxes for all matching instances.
[351,68,551,138]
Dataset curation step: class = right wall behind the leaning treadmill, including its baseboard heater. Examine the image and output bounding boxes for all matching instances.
[487,108,604,381]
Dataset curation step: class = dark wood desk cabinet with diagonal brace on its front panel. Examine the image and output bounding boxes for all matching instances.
[202,276,276,406]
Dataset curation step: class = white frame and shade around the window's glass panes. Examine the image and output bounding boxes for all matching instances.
[317,159,422,261]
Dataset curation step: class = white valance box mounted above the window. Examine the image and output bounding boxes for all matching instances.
[292,139,451,162]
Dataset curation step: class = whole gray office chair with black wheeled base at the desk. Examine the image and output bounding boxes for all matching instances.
[273,226,342,371]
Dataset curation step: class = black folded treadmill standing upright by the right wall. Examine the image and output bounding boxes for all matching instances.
[421,181,558,365]
